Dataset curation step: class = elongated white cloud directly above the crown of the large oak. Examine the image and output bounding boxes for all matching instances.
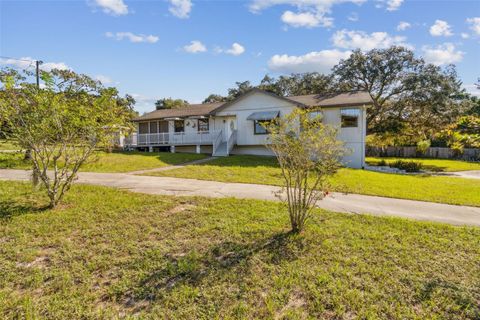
[332,29,411,51]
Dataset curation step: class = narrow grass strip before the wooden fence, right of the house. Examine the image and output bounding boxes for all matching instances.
[366,157,480,172]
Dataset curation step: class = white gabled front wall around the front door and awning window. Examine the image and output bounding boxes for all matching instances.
[216,93,295,146]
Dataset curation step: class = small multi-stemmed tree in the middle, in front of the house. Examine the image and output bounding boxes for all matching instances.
[266,109,345,232]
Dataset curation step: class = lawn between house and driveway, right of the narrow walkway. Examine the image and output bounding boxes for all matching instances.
[148,156,480,206]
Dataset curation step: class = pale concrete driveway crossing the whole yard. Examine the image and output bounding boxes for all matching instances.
[0,169,480,226]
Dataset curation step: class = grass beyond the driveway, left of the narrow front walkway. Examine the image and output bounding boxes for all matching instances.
[0,151,206,172]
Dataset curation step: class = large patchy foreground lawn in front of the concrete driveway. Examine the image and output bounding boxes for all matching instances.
[0,181,480,319]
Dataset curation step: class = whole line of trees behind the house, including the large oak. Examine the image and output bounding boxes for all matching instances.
[157,46,480,147]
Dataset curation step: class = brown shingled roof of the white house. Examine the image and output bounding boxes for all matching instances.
[133,89,373,121]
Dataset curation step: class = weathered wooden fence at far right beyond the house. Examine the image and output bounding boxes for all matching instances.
[366,146,480,161]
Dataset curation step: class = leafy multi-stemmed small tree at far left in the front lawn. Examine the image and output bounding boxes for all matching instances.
[0,70,132,208]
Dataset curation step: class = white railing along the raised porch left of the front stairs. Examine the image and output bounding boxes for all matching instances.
[125,131,221,146]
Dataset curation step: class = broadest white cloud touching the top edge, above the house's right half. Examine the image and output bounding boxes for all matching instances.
[250,0,366,28]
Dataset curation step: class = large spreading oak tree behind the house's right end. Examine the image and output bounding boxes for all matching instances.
[333,46,467,140]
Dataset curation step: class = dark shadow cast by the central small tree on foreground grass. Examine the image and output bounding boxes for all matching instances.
[117,232,306,311]
